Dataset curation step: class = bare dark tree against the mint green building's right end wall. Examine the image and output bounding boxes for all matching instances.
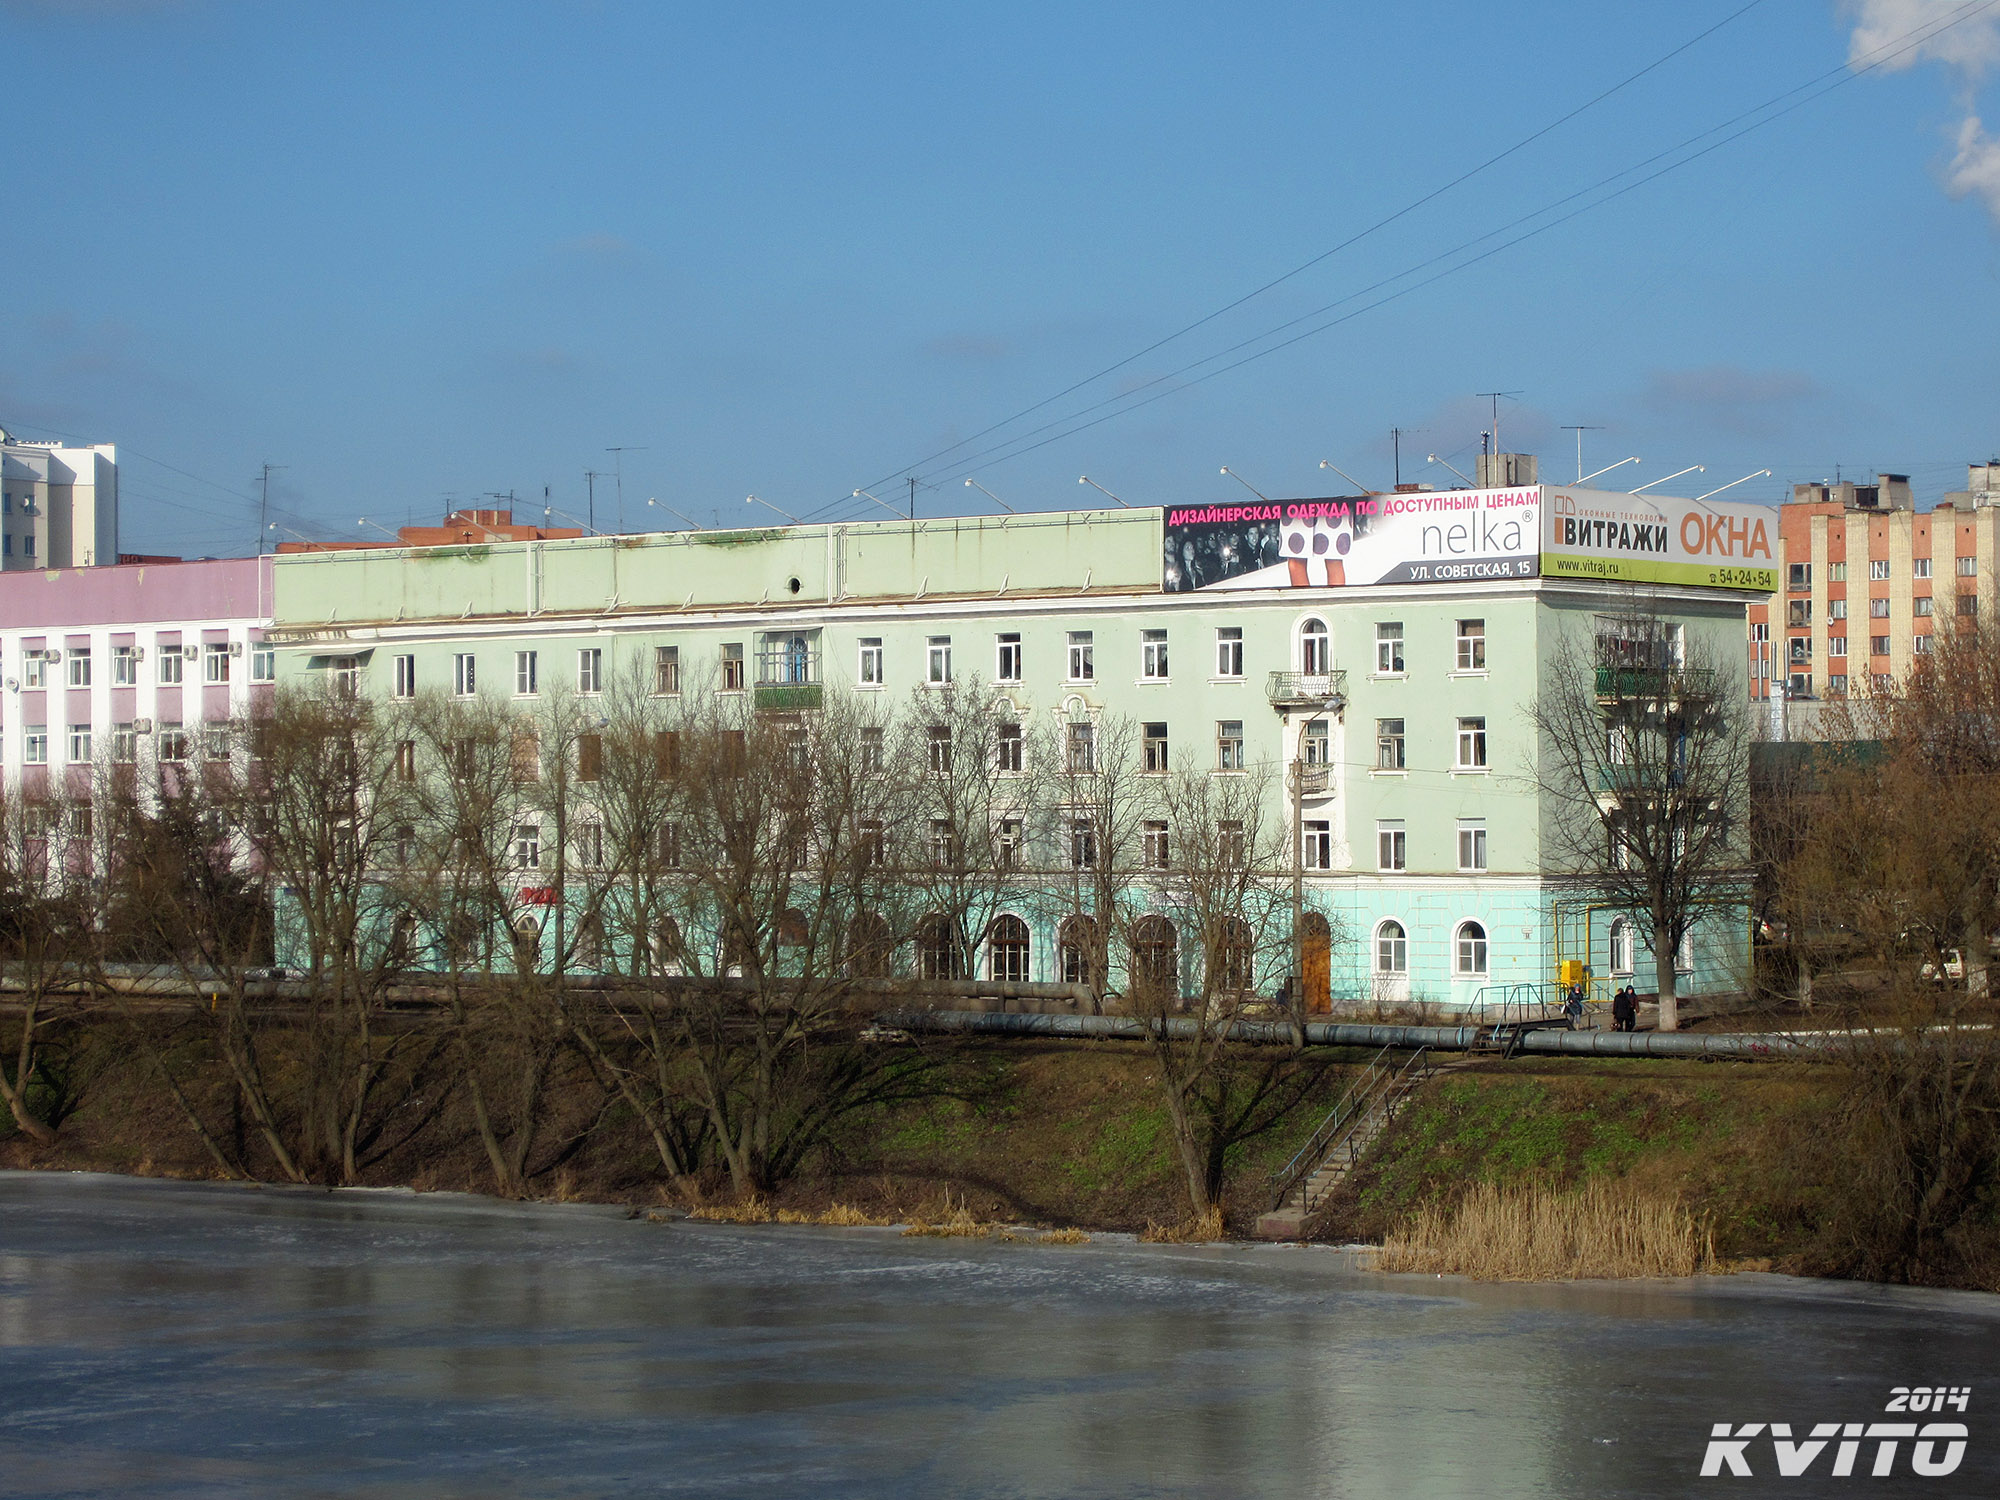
[1524,612,1750,1030]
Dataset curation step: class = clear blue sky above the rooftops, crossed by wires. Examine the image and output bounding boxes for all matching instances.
[0,0,2000,554]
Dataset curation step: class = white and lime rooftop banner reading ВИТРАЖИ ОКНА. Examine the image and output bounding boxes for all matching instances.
[1542,484,1778,594]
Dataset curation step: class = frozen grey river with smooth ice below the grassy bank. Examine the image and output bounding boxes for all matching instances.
[0,1174,2000,1500]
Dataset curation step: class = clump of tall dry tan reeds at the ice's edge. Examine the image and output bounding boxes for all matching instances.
[1374,1182,1716,1282]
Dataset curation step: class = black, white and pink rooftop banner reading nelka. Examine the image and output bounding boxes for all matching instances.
[1162,484,1542,594]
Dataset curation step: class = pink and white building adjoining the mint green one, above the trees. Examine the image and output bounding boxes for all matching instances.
[0,558,274,792]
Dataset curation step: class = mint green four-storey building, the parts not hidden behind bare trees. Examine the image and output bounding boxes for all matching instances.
[272,502,1750,1006]
